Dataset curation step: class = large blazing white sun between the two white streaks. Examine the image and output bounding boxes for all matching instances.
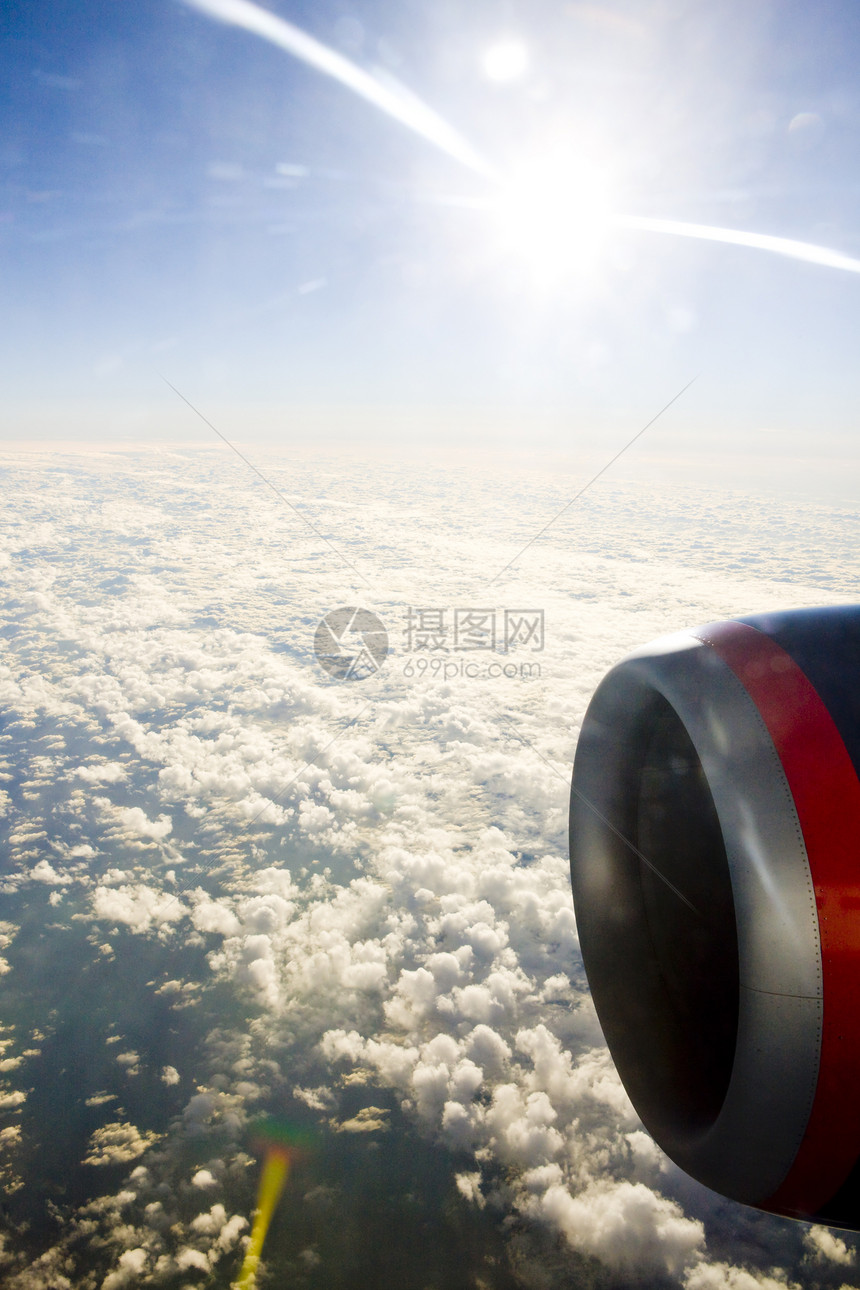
[495,156,612,285]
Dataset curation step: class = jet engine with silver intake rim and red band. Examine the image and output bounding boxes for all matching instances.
[570,606,860,1229]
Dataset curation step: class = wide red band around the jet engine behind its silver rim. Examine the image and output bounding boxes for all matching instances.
[695,623,860,1216]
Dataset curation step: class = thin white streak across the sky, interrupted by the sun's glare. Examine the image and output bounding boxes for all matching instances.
[183,0,860,273]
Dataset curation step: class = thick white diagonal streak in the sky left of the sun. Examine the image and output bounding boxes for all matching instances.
[184,0,496,179]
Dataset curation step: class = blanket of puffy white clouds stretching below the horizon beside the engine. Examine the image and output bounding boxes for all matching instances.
[0,452,855,1290]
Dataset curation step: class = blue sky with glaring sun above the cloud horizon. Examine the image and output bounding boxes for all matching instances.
[0,0,860,485]
